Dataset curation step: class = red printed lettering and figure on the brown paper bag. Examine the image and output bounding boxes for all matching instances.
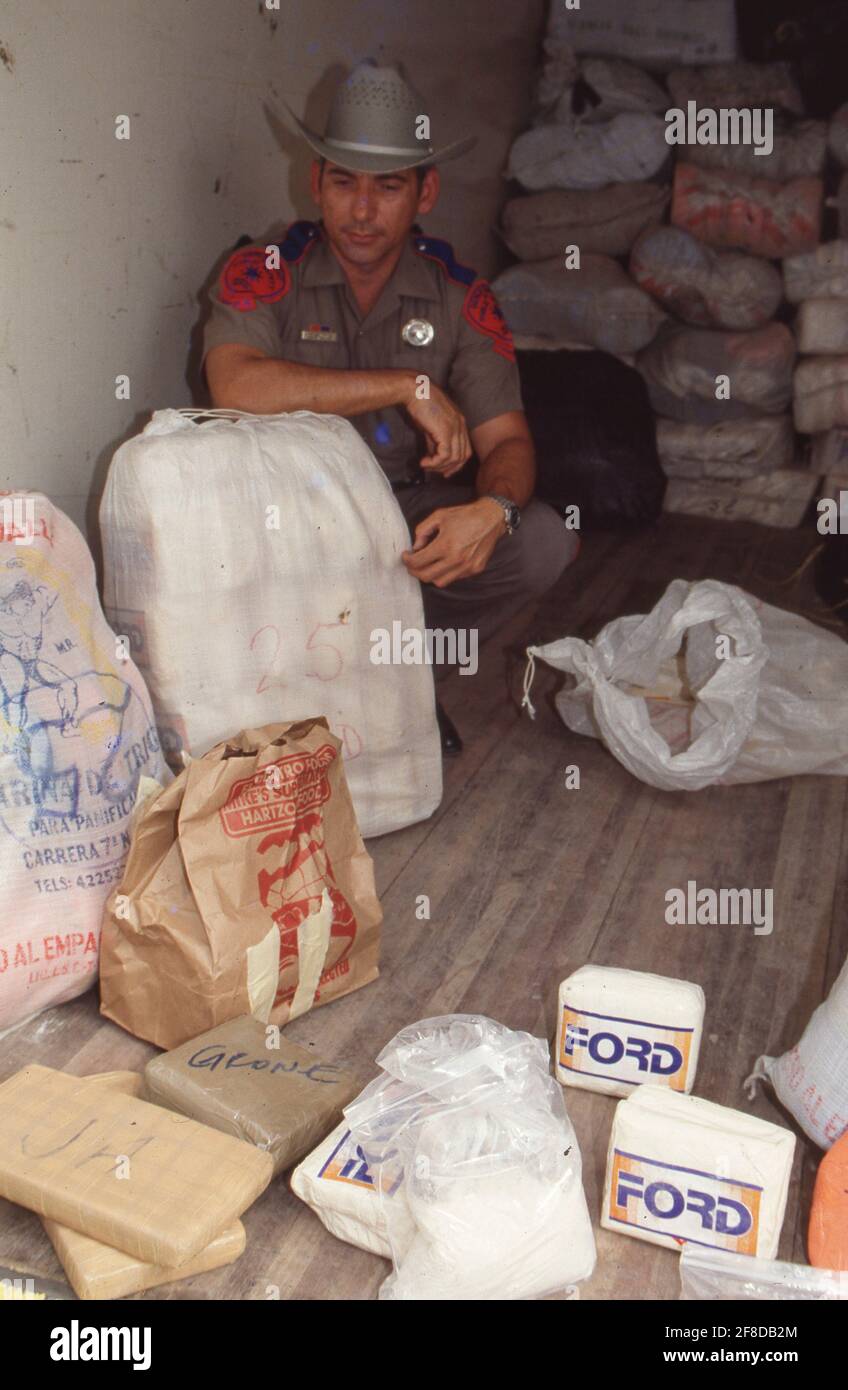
[220,744,356,1005]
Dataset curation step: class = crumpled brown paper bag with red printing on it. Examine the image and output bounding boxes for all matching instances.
[100,719,382,1048]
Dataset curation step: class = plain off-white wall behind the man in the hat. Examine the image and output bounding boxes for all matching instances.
[0,0,545,537]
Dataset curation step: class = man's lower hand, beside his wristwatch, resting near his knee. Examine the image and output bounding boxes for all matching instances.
[402,498,506,589]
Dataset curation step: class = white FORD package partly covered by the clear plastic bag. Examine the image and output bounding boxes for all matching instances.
[292,1120,406,1259]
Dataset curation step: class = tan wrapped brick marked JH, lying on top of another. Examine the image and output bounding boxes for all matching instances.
[0,1063,274,1266]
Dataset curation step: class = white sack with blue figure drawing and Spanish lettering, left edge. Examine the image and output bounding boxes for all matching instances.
[0,492,164,1034]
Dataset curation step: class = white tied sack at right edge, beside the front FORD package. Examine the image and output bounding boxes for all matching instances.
[745,960,848,1148]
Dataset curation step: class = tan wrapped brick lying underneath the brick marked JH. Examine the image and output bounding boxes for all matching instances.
[42,1072,246,1298]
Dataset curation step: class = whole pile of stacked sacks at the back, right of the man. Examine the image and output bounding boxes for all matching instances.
[495,0,848,525]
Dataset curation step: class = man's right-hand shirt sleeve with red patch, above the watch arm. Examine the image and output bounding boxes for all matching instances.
[448,279,524,430]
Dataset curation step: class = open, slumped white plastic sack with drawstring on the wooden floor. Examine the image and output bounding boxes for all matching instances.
[525,580,848,791]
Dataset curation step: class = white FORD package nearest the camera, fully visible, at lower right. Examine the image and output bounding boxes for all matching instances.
[601,1086,795,1259]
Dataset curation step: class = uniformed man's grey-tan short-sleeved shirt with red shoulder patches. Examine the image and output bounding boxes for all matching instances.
[204,222,523,484]
